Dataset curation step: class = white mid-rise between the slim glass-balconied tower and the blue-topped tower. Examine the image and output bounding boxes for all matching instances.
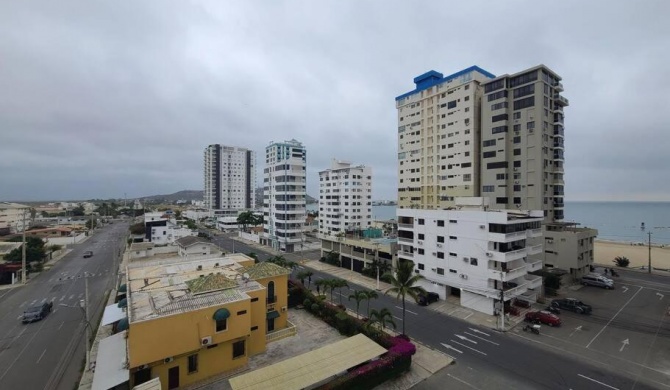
[319,159,372,236]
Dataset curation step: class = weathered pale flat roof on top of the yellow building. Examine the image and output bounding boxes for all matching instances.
[126,255,266,324]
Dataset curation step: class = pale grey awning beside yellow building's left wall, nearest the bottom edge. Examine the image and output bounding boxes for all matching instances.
[91,332,130,390]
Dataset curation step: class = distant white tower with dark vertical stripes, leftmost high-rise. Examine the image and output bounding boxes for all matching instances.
[203,144,256,210]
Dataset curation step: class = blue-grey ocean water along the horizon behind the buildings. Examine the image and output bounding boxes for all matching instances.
[307,202,670,244]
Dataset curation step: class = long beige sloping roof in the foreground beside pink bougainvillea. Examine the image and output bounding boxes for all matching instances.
[228,334,386,390]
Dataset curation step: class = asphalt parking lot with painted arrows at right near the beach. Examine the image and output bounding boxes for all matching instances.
[515,277,670,386]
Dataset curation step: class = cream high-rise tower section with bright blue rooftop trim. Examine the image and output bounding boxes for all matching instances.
[396,66,494,209]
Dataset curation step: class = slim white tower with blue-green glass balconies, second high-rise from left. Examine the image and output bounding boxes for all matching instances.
[261,140,307,252]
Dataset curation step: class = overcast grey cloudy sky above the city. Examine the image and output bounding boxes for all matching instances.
[0,0,670,201]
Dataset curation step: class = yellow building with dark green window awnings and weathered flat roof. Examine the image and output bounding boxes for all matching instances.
[126,254,289,389]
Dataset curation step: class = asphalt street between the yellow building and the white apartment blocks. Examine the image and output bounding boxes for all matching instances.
[213,236,670,390]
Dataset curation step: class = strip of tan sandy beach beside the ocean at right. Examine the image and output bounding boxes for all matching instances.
[593,240,670,269]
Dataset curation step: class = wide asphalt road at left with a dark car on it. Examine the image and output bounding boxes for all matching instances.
[0,222,128,390]
